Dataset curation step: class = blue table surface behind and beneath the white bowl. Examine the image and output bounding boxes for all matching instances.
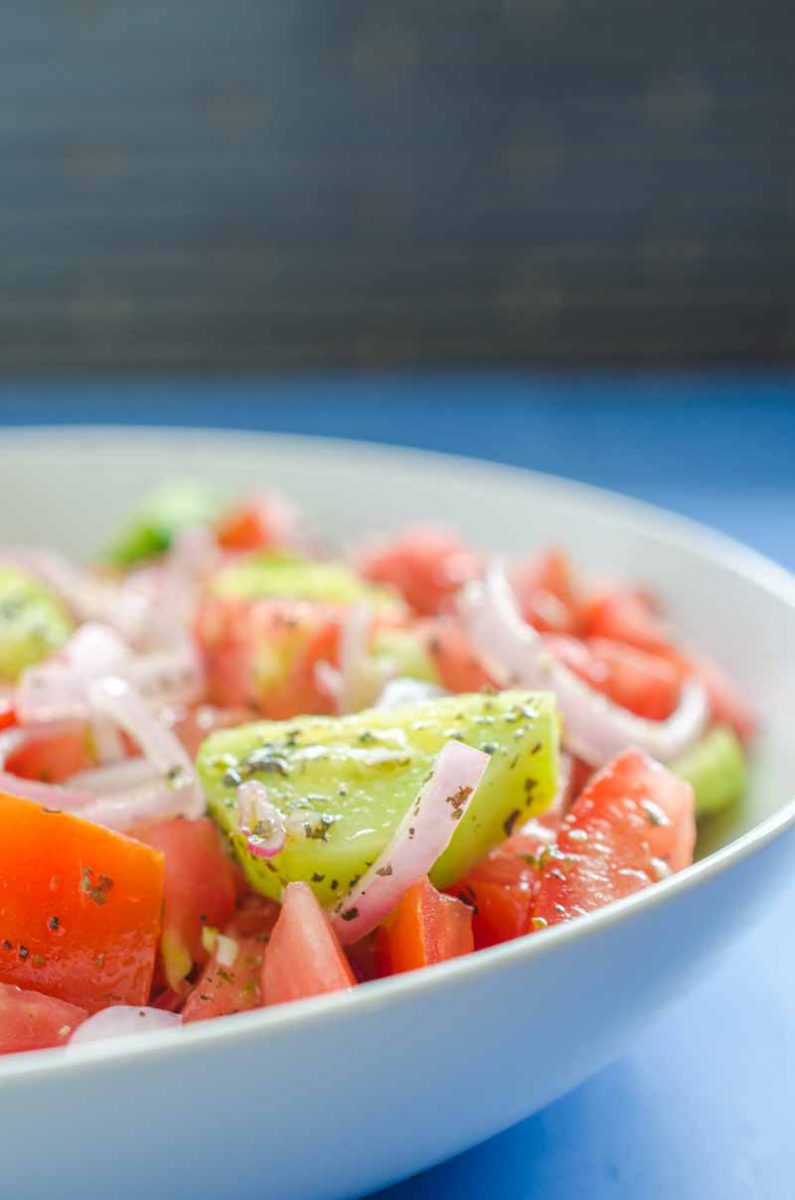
[0,372,795,1200]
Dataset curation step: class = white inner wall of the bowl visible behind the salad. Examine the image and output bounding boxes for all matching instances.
[0,428,795,848]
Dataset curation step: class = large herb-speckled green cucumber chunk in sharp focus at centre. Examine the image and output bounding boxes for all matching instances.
[197,691,558,905]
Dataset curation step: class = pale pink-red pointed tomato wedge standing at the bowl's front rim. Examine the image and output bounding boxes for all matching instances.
[262,883,355,1004]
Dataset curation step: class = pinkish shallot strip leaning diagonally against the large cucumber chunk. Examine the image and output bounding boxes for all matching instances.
[330,740,490,944]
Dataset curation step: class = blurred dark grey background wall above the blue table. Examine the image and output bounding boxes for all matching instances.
[0,0,795,370]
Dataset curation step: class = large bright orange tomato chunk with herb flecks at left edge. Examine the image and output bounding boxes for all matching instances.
[0,793,163,1012]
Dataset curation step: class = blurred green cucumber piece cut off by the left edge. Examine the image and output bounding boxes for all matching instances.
[0,566,74,682]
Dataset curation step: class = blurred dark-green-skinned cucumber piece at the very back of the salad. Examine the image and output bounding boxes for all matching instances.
[104,479,221,568]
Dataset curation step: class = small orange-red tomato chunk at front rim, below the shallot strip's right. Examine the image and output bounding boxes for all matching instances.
[377,877,474,974]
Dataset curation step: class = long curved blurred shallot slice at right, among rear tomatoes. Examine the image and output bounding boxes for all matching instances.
[459,566,707,767]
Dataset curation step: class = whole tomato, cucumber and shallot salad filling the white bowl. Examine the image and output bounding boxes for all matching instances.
[0,482,755,1054]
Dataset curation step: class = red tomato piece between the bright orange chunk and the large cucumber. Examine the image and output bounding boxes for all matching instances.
[135,817,237,995]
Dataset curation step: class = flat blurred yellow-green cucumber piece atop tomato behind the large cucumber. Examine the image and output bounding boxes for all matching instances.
[208,551,404,614]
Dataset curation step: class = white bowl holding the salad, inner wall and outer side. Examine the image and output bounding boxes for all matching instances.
[0,428,795,1200]
